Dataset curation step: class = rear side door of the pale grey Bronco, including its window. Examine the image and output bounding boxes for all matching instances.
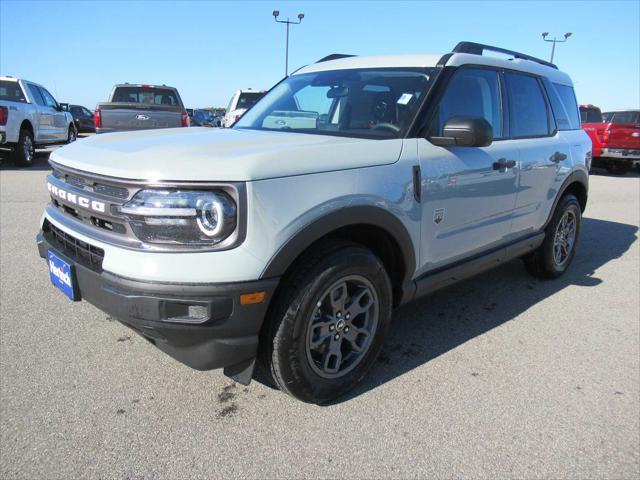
[505,72,579,237]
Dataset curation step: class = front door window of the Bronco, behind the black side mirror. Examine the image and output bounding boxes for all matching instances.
[431,68,503,138]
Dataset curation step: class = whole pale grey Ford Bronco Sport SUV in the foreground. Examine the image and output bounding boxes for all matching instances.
[37,42,591,403]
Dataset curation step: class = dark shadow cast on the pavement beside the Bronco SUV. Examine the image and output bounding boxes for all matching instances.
[333,218,638,404]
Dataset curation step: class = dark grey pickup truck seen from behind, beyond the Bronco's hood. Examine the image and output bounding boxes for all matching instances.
[95,83,189,133]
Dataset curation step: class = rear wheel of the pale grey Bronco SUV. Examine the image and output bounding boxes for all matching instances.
[524,194,582,278]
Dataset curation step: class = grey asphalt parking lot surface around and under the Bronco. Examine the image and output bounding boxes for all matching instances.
[0,150,640,479]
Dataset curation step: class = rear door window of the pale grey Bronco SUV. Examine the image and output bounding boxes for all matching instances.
[505,73,549,137]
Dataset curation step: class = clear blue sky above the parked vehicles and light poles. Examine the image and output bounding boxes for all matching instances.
[0,0,640,110]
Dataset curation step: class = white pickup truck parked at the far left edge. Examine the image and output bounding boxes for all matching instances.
[0,77,77,166]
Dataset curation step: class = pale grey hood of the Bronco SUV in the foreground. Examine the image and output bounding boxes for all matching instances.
[51,127,402,181]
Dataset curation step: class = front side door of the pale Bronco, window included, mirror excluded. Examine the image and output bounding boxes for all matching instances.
[418,67,519,273]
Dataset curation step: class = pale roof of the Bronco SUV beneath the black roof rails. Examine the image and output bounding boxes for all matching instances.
[293,53,573,85]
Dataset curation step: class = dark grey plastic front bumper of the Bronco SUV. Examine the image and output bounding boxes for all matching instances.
[36,231,278,383]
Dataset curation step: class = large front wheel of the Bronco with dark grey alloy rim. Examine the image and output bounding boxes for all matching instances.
[261,241,392,404]
